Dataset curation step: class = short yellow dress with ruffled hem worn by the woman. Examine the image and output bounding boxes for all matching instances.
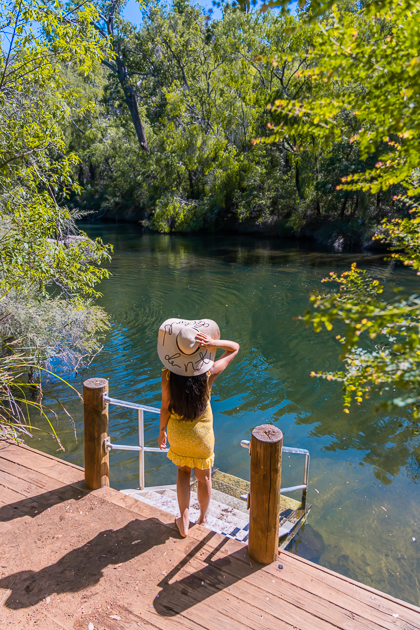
[167,370,214,470]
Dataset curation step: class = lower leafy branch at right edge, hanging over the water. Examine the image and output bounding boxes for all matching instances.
[301,264,420,418]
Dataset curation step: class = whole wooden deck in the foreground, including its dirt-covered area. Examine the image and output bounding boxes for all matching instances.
[0,442,420,630]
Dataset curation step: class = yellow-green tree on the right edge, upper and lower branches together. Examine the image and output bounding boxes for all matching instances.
[262,1,420,418]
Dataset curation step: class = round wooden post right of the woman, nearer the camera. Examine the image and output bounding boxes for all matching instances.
[248,424,283,564]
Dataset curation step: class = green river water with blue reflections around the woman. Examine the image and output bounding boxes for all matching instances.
[29,225,420,605]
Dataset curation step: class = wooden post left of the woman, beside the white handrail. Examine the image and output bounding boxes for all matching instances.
[83,378,109,490]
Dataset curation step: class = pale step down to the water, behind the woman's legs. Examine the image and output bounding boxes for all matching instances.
[122,490,249,542]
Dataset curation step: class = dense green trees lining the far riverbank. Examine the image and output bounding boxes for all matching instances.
[66,0,406,249]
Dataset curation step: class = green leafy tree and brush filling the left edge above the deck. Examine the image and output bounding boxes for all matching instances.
[0,0,109,444]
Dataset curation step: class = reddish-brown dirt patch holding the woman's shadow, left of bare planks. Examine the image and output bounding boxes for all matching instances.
[0,486,220,630]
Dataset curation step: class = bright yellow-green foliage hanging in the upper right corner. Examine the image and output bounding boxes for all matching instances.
[271,2,420,200]
